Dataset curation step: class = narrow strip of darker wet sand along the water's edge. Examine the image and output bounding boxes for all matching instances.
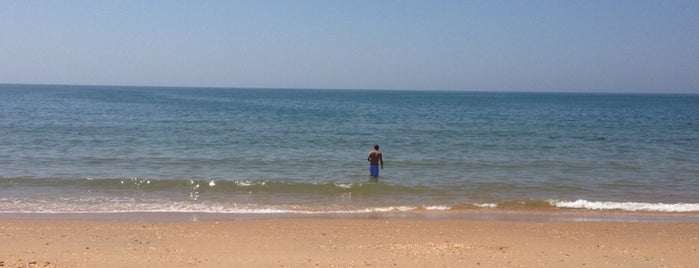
[0,208,699,223]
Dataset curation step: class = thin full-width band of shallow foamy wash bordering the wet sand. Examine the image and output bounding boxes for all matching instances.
[0,197,699,214]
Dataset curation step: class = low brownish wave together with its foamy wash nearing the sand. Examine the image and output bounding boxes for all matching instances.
[0,178,699,214]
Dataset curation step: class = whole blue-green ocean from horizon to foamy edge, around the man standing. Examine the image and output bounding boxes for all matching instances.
[0,85,699,217]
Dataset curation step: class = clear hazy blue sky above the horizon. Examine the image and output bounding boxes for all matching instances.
[0,0,699,93]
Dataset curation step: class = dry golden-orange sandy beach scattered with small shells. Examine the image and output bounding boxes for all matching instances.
[0,219,699,267]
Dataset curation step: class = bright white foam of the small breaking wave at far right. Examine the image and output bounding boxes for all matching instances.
[550,199,699,212]
